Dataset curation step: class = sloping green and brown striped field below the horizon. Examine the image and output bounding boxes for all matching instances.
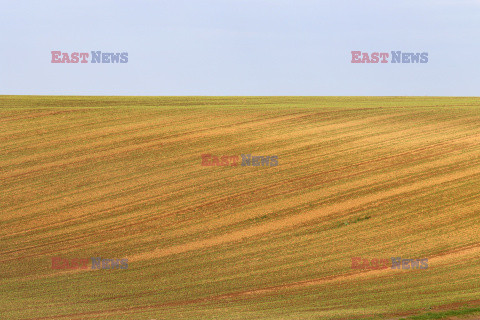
[0,96,480,320]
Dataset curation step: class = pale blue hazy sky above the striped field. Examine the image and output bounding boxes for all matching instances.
[0,0,480,96]
